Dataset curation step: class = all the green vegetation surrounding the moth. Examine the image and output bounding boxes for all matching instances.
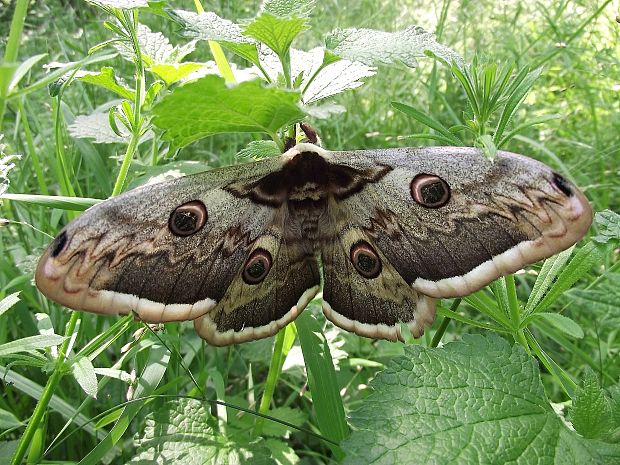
[0,0,620,464]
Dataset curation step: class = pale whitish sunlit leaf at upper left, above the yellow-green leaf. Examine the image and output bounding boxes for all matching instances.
[114,24,196,66]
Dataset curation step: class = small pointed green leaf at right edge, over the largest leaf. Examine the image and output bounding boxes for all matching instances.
[569,367,613,439]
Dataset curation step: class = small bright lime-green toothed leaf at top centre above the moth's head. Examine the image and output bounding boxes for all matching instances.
[243,13,308,58]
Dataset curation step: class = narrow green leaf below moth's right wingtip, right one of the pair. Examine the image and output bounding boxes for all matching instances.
[533,242,603,312]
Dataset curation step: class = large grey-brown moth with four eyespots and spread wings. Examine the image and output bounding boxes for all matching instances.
[36,143,592,345]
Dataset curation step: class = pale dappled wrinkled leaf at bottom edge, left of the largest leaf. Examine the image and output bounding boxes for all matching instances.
[128,399,276,465]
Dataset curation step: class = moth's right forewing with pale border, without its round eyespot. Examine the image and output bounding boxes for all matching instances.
[334,147,592,297]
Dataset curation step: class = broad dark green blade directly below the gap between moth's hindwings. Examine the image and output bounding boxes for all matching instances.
[295,312,349,442]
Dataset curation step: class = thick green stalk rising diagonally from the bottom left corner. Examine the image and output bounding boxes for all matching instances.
[10,312,80,465]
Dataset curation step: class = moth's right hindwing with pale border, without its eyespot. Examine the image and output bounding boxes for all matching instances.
[321,199,435,340]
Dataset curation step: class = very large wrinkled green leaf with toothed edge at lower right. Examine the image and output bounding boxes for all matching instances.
[342,335,620,465]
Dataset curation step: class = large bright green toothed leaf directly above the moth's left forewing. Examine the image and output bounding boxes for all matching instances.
[153,76,305,147]
